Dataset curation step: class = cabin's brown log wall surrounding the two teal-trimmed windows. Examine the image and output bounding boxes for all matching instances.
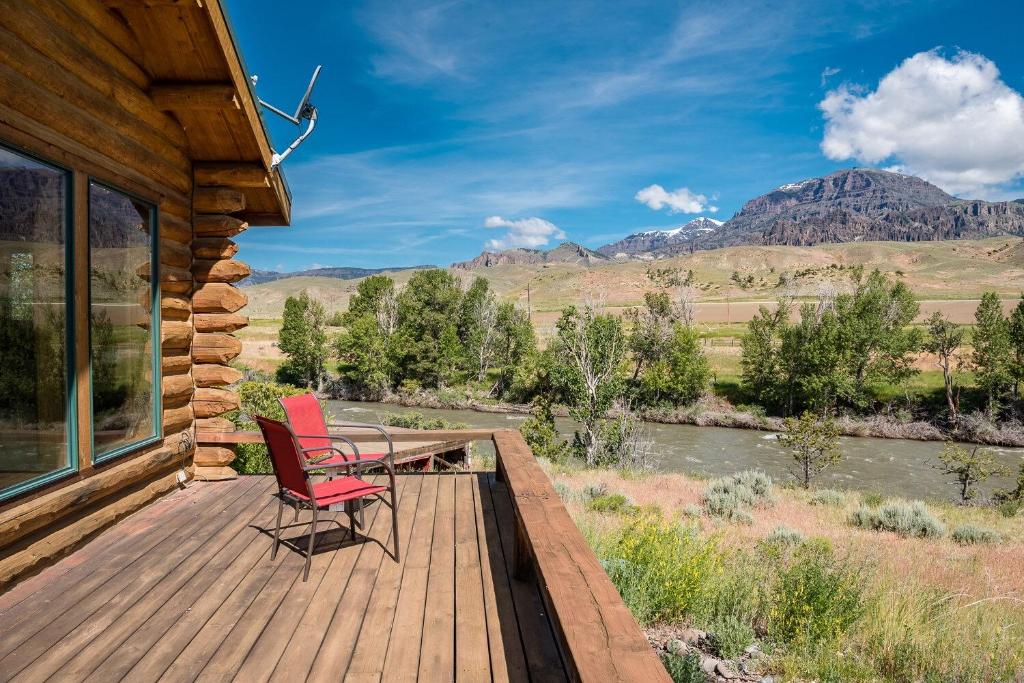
[0,0,195,587]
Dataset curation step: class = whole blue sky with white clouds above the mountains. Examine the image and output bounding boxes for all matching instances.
[226,0,1024,270]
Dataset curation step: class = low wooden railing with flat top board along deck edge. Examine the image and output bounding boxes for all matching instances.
[197,428,671,683]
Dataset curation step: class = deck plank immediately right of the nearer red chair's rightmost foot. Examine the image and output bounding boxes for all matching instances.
[381,474,440,681]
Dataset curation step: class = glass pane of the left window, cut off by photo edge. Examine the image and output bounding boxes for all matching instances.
[0,147,70,493]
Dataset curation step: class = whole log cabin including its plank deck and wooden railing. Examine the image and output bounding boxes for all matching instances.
[0,0,668,681]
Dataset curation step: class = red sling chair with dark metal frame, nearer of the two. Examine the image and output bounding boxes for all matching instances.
[255,416,398,581]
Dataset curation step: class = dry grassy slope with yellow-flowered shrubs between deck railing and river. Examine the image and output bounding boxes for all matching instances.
[549,466,1024,681]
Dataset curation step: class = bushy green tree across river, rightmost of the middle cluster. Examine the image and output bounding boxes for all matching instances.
[640,323,711,405]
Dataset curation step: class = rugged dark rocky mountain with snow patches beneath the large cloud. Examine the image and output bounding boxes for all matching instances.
[598,168,1024,257]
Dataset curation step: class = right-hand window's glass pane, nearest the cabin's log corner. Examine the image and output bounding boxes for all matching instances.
[89,183,156,459]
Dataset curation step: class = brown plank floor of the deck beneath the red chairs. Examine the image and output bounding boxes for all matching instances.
[0,473,571,683]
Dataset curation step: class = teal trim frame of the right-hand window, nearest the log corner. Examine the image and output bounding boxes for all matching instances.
[85,177,164,465]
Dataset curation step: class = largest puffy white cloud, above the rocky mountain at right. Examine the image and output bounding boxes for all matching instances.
[818,49,1024,197]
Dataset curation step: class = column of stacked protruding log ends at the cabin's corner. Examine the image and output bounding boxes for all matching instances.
[190,181,250,480]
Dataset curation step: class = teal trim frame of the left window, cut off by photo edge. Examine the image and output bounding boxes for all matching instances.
[0,140,81,501]
